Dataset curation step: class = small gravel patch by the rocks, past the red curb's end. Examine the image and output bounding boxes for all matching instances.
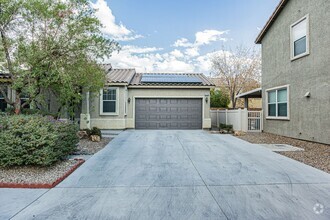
[75,138,112,155]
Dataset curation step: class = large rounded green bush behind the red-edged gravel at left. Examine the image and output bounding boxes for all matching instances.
[0,115,79,167]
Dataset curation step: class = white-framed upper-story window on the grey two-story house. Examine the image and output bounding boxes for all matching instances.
[291,15,309,60]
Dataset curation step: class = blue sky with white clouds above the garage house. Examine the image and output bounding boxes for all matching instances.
[92,0,279,75]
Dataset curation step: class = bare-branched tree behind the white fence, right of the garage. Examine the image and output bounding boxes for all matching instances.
[211,46,261,108]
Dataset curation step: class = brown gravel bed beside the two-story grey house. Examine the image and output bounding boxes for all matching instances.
[238,133,330,173]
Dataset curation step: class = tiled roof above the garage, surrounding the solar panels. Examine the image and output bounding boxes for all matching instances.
[130,73,214,86]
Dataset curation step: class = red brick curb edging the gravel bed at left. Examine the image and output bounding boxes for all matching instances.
[0,159,85,189]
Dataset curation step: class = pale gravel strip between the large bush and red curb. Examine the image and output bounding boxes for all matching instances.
[0,160,79,184]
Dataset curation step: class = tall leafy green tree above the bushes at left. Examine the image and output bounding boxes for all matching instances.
[0,0,119,114]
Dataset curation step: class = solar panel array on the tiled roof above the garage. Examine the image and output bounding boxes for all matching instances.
[141,74,202,83]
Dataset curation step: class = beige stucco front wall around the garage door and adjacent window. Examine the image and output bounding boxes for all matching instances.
[82,87,211,129]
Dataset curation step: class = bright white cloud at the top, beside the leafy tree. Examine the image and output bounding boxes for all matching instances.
[91,0,143,41]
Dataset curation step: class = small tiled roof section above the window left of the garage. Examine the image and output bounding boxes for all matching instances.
[106,69,136,84]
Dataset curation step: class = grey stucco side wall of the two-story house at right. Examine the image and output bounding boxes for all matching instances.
[262,0,330,144]
